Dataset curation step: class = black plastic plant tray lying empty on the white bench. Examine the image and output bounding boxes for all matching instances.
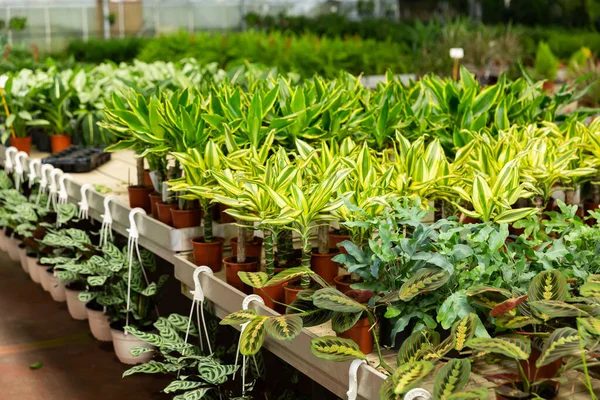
[42,146,110,172]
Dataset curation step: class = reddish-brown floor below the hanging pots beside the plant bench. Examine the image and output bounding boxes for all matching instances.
[0,252,170,400]
